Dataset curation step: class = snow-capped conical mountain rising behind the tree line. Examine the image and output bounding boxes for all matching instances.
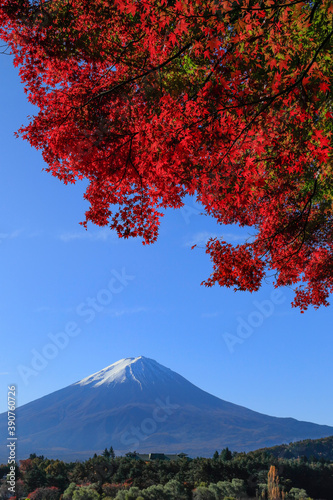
[0,356,333,463]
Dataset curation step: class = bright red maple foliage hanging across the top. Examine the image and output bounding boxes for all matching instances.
[0,0,333,311]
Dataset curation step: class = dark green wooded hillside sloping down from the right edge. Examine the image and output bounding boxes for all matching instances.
[256,436,333,462]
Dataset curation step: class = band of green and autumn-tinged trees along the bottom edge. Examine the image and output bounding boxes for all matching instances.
[0,449,333,500]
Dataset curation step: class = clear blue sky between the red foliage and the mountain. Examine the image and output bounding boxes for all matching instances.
[0,55,333,432]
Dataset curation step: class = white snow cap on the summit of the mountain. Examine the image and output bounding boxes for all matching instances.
[74,356,177,389]
